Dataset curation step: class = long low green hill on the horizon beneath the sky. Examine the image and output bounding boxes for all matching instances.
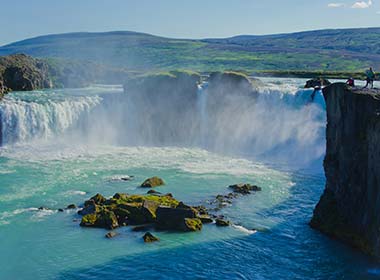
[0,28,380,72]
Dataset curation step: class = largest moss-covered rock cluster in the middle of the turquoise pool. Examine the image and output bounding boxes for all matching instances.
[78,193,212,232]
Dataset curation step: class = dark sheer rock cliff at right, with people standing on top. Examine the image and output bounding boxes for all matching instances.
[310,83,380,257]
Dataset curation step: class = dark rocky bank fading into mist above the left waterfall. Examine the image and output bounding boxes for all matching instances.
[0,54,131,98]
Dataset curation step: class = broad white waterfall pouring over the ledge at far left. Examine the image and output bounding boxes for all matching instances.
[0,93,99,145]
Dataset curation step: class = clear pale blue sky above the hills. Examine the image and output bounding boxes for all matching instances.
[0,0,380,45]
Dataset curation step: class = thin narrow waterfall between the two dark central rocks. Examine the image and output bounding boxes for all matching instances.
[197,82,208,147]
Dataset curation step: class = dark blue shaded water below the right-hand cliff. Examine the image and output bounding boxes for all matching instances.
[58,174,378,280]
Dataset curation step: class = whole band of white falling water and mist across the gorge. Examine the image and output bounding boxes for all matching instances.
[0,79,325,166]
